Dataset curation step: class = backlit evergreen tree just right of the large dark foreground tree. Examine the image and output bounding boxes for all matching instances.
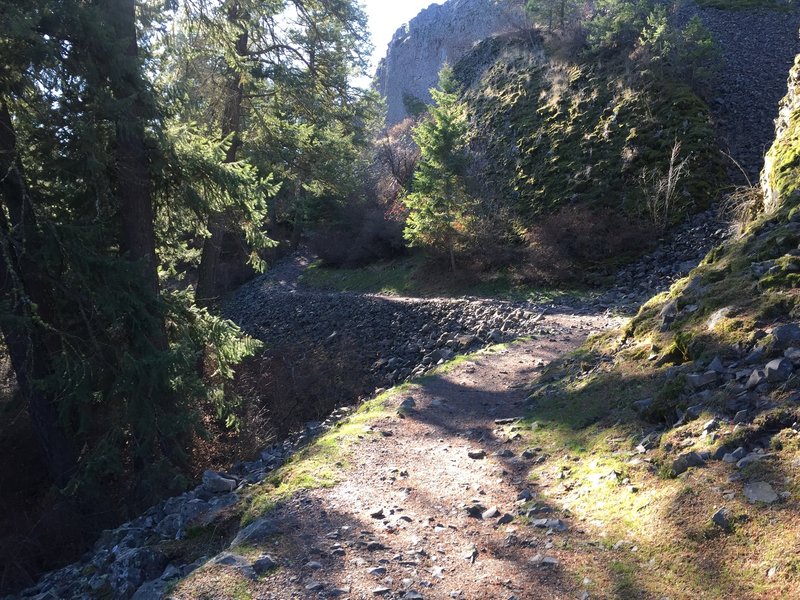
[162,0,374,304]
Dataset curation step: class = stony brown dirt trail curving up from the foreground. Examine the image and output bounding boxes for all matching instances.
[178,315,612,599]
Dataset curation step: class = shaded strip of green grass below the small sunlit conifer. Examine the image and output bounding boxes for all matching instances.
[300,254,590,302]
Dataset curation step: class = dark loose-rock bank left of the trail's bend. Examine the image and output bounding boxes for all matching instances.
[226,288,544,385]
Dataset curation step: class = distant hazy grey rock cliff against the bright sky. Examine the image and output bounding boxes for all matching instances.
[375,0,526,125]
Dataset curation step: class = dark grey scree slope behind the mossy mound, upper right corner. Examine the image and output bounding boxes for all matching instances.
[678,2,800,185]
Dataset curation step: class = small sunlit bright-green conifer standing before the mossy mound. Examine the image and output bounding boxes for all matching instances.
[404,65,474,271]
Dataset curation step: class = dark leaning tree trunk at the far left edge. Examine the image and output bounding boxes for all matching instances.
[0,98,78,486]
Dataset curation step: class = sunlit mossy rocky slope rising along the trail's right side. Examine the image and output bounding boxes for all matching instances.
[510,57,800,599]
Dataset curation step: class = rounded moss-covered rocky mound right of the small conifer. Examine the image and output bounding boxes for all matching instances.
[456,38,725,223]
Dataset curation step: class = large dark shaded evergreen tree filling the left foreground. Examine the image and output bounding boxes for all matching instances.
[0,0,257,502]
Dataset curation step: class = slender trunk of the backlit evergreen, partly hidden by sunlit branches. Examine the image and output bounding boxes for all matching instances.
[195,9,248,306]
